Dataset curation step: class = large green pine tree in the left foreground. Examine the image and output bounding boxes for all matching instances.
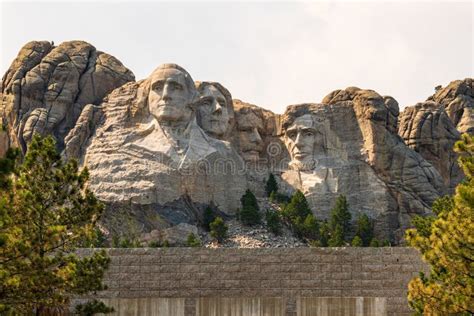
[0,135,110,315]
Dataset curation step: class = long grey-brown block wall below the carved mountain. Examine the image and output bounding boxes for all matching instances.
[76,247,427,316]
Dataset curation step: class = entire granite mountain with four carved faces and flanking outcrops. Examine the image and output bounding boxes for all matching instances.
[0,41,474,242]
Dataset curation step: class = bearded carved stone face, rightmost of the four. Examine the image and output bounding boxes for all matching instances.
[285,114,317,169]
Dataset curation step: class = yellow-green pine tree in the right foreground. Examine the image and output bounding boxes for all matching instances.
[406,134,474,315]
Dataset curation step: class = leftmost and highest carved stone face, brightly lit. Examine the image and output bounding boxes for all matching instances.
[148,68,193,122]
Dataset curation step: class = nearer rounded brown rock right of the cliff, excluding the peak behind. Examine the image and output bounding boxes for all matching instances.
[399,101,463,191]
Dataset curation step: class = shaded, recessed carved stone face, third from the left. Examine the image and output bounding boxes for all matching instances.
[237,111,264,162]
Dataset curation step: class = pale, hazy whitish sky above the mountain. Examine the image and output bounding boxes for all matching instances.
[0,1,474,113]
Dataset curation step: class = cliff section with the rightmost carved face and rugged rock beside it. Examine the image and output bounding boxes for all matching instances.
[294,87,445,239]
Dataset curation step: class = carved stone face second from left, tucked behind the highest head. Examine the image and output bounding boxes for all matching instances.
[198,85,230,137]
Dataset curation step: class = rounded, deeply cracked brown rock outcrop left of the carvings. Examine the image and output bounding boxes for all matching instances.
[0,41,134,152]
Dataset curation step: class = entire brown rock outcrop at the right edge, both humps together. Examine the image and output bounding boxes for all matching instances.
[398,78,474,193]
